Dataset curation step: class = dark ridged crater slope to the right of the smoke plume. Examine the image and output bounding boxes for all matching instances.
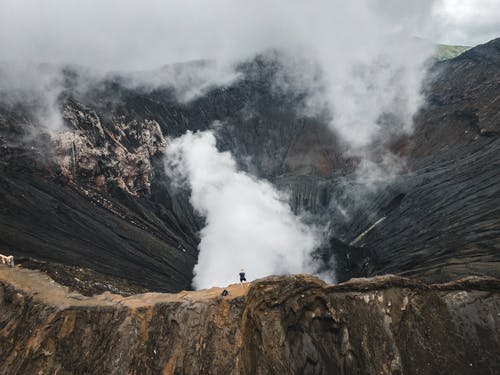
[332,39,500,281]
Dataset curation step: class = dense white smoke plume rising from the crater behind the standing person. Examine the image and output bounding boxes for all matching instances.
[165,131,319,289]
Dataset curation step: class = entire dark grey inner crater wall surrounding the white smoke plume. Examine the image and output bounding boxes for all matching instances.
[0,39,500,291]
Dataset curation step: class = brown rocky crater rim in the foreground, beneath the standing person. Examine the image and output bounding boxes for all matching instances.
[0,266,500,374]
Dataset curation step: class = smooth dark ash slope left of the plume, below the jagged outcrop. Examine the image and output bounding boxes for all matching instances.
[0,117,197,291]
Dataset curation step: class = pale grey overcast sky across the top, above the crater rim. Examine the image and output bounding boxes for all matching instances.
[0,0,500,69]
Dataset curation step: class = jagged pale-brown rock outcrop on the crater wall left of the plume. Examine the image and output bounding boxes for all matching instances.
[52,102,166,196]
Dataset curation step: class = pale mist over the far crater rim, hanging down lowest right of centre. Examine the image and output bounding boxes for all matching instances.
[0,0,442,150]
